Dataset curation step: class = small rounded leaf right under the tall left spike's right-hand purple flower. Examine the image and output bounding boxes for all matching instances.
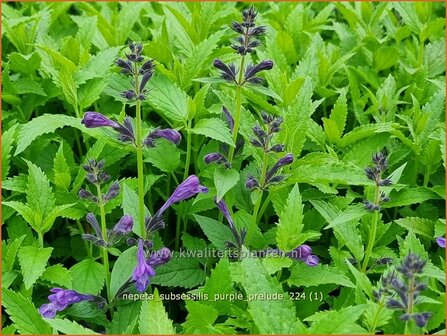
[144,140,180,173]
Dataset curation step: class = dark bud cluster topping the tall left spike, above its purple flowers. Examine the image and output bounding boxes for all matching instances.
[116,42,154,100]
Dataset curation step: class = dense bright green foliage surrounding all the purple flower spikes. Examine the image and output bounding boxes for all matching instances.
[2,2,445,334]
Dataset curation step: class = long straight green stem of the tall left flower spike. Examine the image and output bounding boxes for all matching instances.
[134,63,146,239]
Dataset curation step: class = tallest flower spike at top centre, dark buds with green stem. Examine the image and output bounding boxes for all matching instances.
[213,6,273,164]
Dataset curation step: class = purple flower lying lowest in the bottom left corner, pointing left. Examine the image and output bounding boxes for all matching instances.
[39,288,96,318]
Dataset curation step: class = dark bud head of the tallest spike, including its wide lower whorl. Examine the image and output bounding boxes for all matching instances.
[213,7,273,85]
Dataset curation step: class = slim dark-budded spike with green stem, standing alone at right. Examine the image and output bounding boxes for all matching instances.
[362,152,392,272]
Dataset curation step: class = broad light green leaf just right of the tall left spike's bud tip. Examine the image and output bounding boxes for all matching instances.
[147,75,188,122]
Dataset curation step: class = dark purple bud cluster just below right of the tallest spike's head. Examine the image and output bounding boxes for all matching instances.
[245,112,294,190]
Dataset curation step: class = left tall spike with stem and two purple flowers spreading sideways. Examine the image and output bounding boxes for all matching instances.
[82,42,182,239]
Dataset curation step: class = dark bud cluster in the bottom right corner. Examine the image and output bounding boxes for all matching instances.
[373,253,432,327]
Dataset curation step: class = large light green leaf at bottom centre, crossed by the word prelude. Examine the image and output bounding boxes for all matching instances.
[241,258,297,334]
